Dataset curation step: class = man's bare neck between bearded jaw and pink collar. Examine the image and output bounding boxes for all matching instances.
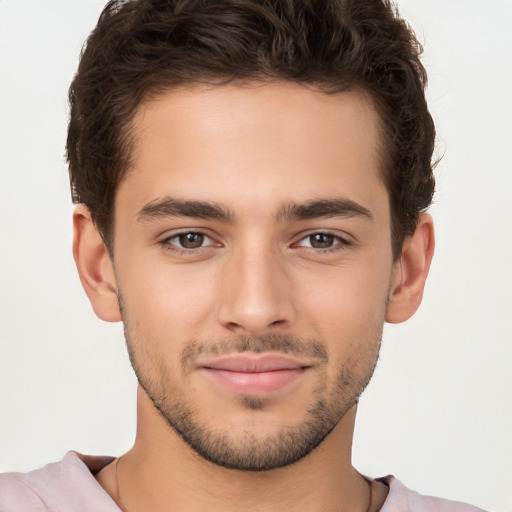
[98,390,378,512]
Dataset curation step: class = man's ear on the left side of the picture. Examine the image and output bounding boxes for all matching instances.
[73,205,121,322]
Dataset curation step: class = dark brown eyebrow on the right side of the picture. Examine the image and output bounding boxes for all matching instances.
[276,198,373,221]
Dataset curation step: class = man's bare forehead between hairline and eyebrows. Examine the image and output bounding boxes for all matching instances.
[118,82,383,220]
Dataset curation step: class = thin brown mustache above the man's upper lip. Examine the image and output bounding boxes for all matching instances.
[181,334,329,368]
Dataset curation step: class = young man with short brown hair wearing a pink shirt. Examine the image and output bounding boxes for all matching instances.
[0,0,488,512]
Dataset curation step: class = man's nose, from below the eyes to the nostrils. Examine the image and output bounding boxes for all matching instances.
[218,244,294,337]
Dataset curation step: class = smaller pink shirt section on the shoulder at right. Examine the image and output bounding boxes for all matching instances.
[377,476,484,512]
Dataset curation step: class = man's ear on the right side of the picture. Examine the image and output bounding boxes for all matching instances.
[386,213,435,324]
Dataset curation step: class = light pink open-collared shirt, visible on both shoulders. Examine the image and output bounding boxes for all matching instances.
[0,452,483,512]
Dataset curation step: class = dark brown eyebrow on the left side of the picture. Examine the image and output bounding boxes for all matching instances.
[137,196,234,221]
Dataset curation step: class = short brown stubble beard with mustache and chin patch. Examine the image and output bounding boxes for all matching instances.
[120,301,382,471]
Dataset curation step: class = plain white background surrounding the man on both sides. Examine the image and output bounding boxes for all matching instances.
[0,0,512,512]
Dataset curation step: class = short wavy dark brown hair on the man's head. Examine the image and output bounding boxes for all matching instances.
[67,0,435,257]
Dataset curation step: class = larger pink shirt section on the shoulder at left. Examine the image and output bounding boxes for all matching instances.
[0,452,119,512]
